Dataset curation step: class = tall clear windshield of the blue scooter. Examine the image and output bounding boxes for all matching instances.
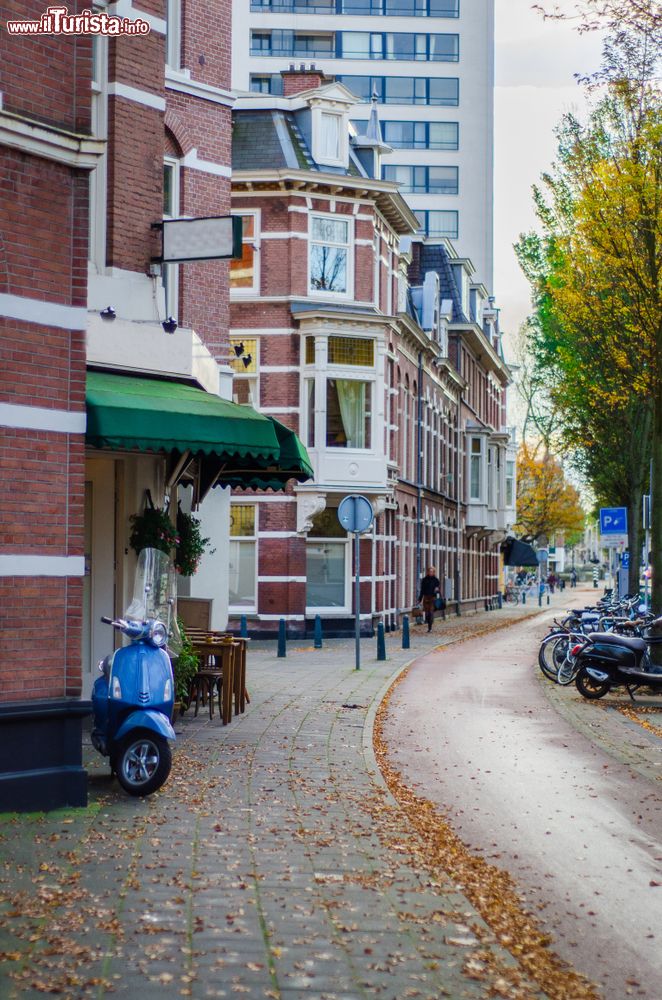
[124,549,181,653]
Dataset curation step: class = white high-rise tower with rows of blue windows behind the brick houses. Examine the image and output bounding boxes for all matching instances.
[232,0,494,289]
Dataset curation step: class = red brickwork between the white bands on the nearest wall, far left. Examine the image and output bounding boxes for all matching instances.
[0,19,92,702]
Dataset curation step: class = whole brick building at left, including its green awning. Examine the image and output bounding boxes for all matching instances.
[0,0,312,809]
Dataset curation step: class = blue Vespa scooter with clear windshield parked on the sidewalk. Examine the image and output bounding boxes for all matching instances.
[92,549,181,795]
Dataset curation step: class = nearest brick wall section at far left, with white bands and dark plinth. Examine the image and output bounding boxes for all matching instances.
[0,0,102,808]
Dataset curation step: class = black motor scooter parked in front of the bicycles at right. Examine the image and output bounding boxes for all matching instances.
[572,618,662,701]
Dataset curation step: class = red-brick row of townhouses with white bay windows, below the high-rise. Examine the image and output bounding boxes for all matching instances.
[230,67,514,634]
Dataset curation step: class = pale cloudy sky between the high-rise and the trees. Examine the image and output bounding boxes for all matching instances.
[494,0,600,344]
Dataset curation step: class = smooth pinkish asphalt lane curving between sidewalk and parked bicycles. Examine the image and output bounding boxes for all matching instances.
[383,600,662,1000]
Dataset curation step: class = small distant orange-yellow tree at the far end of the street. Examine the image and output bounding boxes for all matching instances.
[515,444,585,542]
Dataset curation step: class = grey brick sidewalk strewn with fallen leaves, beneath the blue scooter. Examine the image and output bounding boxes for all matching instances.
[0,606,560,1000]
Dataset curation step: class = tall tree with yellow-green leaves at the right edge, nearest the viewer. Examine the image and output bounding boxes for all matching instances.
[517,25,662,608]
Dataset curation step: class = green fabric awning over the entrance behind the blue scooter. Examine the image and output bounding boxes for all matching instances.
[86,372,313,489]
